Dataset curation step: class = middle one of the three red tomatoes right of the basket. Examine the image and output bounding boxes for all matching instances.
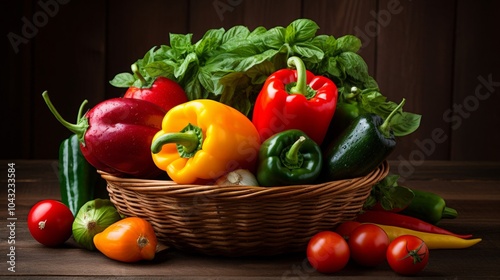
[349,224,390,267]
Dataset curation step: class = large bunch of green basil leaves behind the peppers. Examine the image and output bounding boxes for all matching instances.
[106,15,420,132]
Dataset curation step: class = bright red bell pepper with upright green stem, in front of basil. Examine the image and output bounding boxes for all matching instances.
[252,57,338,145]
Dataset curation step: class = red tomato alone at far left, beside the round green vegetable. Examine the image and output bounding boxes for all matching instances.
[28,199,74,247]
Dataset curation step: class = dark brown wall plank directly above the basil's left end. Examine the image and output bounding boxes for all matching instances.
[105,0,189,98]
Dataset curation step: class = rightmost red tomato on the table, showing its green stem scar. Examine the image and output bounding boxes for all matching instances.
[387,235,429,275]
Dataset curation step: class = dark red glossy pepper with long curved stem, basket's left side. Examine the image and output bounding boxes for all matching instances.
[42,91,166,178]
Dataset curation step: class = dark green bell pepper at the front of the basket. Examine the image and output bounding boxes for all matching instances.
[257,129,323,187]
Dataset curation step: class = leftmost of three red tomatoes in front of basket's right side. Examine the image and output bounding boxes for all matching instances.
[307,231,349,273]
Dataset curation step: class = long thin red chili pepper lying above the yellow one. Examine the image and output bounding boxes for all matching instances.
[356,210,472,239]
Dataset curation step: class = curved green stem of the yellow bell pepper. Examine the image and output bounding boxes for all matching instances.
[151,124,203,158]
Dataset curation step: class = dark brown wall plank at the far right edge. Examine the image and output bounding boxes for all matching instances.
[452,0,500,161]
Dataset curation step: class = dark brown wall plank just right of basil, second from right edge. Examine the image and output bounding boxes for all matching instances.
[376,0,455,161]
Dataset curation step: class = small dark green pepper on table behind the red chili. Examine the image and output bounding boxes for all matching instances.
[400,189,458,224]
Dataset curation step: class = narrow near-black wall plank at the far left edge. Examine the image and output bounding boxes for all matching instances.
[0,1,35,159]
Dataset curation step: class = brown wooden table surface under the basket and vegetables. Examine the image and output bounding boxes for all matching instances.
[0,160,500,280]
